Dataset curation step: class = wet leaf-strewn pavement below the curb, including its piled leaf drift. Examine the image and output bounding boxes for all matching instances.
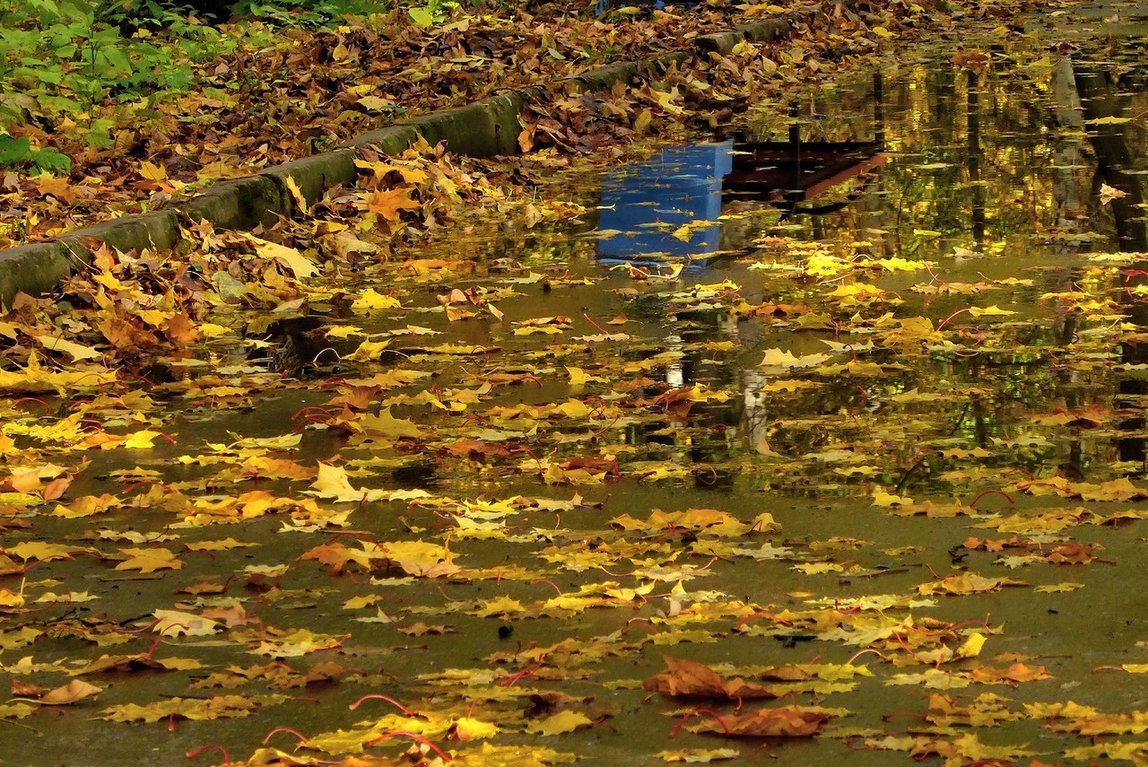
[0,1,1148,767]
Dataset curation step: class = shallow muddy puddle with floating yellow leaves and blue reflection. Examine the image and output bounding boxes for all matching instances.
[0,16,1148,765]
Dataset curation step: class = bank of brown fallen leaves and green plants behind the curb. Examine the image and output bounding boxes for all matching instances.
[0,0,1037,247]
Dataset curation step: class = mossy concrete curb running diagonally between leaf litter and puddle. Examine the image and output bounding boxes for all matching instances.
[0,11,817,305]
